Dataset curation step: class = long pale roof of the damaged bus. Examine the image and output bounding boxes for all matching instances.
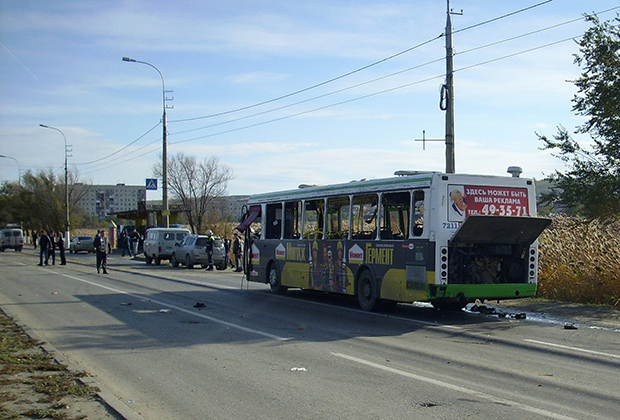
[249,171,526,205]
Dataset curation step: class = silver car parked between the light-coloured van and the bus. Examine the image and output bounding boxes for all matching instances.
[170,235,228,270]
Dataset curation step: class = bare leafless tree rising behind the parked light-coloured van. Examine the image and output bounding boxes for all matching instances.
[153,152,233,233]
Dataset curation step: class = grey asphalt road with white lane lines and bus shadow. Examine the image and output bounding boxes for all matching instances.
[0,250,620,420]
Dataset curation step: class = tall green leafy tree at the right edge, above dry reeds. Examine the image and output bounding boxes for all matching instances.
[537,15,620,220]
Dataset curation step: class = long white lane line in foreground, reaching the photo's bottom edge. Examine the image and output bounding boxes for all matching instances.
[331,352,577,420]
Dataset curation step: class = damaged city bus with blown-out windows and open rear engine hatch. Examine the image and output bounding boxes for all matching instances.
[238,167,551,311]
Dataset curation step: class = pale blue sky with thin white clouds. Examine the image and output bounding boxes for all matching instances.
[0,0,620,199]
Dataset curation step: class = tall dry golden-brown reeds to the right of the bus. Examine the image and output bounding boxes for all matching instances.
[538,216,620,306]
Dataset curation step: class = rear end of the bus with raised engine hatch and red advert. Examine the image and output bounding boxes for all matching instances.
[428,174,551,308]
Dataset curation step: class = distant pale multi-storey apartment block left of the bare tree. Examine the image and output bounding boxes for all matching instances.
[74,184,146,219]
